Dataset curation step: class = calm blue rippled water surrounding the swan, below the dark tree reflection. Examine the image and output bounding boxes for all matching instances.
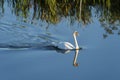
[0,0,120,80]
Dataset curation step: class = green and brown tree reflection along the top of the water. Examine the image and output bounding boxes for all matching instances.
[0,0,120,38]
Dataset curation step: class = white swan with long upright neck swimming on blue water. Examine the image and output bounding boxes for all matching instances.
[54,31,80,50]
